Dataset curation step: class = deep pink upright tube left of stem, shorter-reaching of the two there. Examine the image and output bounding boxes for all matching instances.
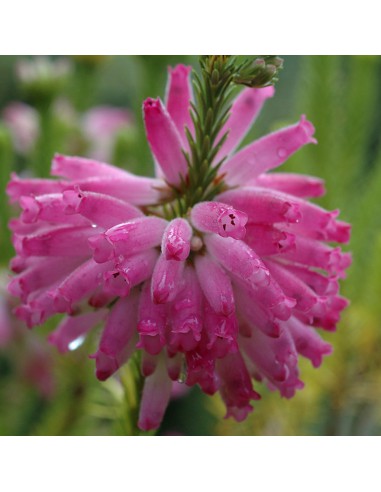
[143,99,188,185]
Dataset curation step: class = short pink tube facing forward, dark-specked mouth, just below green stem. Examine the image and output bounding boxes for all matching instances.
[191,202,247,239]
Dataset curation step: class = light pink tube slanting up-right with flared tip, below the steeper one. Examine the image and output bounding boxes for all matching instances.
[221,116,317,186]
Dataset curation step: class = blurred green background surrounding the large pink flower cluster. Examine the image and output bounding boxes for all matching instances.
[0,56,381,435]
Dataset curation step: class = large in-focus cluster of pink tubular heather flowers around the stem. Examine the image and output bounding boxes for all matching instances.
[8,65,351,430]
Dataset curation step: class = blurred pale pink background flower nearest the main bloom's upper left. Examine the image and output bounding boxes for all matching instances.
[82,106,133,161]
